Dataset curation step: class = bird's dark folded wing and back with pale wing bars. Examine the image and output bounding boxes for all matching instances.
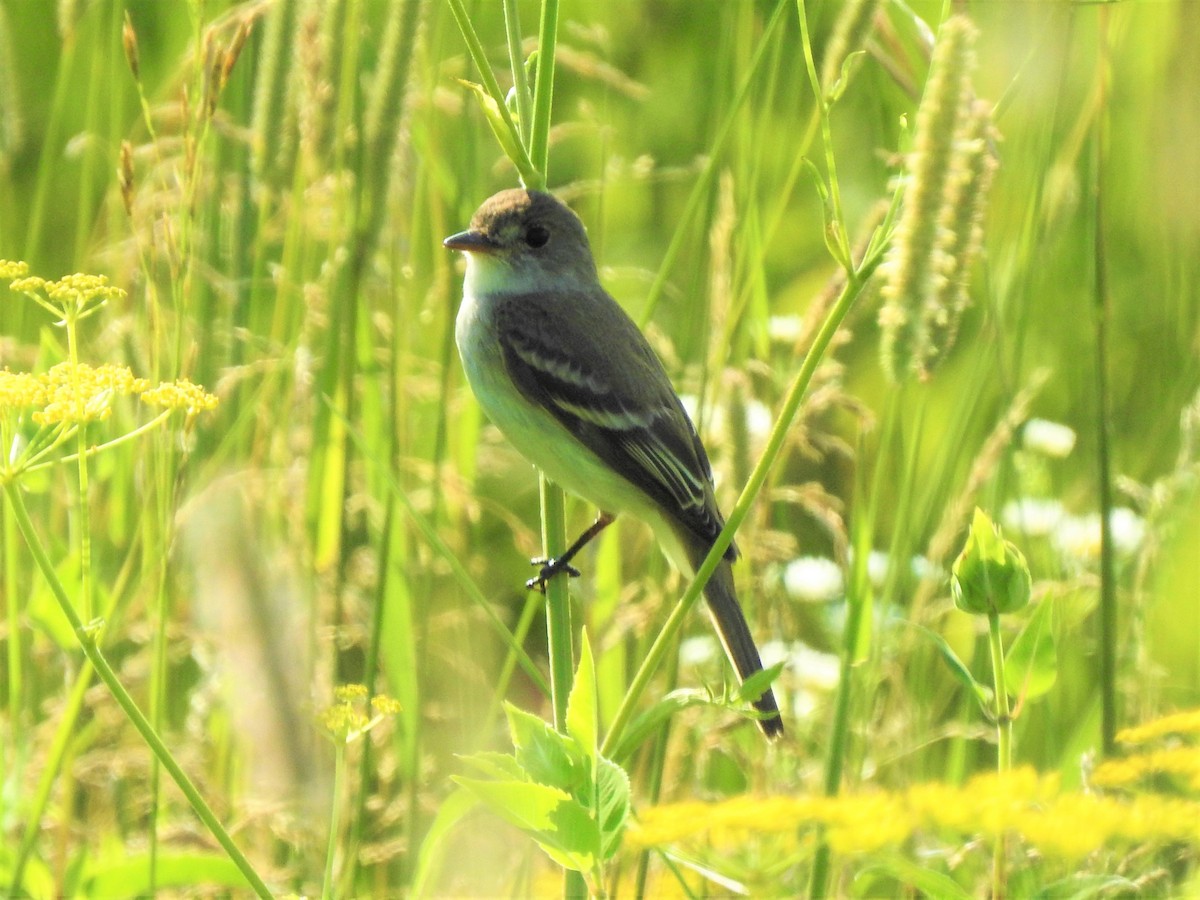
[498,288,737,559]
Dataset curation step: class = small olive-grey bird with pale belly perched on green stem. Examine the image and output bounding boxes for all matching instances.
[443,188,784,739]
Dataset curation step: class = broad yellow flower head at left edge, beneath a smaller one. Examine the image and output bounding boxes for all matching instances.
[0,362,217,425]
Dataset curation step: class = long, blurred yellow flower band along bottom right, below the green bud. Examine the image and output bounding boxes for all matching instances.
[626,768,1200,860]
